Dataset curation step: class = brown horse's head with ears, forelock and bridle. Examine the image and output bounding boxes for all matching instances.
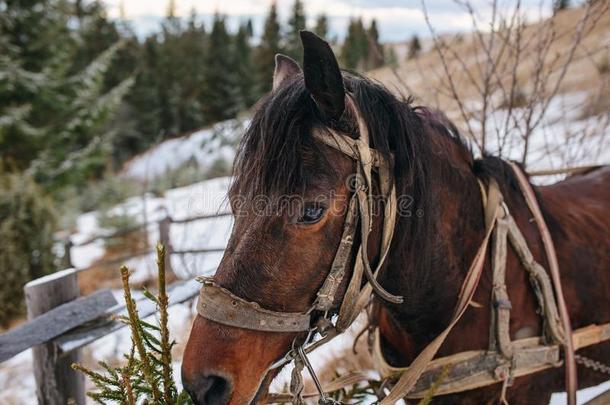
[182,31,432,404]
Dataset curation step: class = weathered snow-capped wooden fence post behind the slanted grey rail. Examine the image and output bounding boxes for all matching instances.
[24,269,85,405]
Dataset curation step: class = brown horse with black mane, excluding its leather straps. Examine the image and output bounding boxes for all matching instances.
[182,32,610,405]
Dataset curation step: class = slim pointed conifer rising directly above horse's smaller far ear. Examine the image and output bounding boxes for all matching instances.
[254,3,282,95]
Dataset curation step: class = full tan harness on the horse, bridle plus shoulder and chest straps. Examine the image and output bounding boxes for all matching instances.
[197,97,610,405]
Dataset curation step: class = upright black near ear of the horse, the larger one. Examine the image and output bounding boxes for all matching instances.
[301,31,345,120]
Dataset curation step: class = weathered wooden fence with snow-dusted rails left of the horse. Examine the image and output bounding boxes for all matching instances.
[0,213,231,405]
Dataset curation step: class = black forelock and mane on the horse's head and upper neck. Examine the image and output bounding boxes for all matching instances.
[231,73,461,199]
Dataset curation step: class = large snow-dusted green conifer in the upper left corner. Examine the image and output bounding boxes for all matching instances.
[0,0,131,189]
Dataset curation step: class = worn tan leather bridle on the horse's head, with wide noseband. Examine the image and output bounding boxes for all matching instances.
[197,96,402,395]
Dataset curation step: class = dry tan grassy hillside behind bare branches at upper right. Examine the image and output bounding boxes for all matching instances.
[369,2,610,121]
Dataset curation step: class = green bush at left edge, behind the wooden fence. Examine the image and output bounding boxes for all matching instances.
[0,172,56,327]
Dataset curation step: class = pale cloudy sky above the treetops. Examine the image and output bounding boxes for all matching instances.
[104,0,551,42]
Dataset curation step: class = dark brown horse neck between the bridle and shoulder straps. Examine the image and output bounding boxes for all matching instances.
[380,125,484,353]
